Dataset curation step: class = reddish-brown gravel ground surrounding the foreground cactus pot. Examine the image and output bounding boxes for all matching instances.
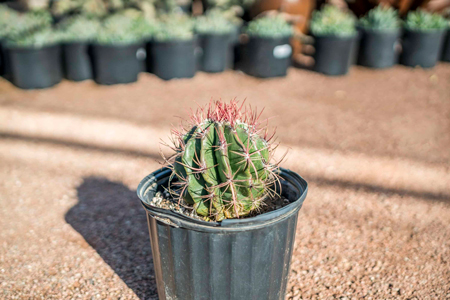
[0,64,450,299]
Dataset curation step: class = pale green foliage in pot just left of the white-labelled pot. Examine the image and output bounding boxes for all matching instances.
[195,14,236,34]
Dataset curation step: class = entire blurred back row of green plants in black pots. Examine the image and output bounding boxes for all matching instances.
[0,5,450,88]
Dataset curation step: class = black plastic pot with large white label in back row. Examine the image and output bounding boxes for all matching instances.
[241,37,292,78]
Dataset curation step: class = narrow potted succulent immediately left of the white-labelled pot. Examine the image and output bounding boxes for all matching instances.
[195,14,236,73]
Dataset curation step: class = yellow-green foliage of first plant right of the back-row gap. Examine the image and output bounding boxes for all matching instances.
[310,4,356,37]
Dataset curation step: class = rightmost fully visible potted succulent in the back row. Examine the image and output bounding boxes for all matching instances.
[400,9,448,68]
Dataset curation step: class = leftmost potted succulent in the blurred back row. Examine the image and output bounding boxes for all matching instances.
[6,27,63,89]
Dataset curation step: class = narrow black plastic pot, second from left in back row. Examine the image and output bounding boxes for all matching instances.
[63,42,94,81]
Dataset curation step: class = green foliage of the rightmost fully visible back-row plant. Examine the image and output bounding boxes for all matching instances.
[404,9,449,31]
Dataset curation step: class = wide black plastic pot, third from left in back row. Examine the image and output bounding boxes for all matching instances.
[93,43,146,85]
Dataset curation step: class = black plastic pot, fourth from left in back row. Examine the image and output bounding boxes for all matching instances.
[147,39,197,80]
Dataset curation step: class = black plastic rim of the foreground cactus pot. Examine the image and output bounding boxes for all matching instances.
[136,168,308,233]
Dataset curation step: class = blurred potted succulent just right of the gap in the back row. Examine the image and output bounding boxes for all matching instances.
[310,5,357,75]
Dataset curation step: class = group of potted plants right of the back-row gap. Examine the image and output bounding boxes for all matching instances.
[310,5,450,75]
